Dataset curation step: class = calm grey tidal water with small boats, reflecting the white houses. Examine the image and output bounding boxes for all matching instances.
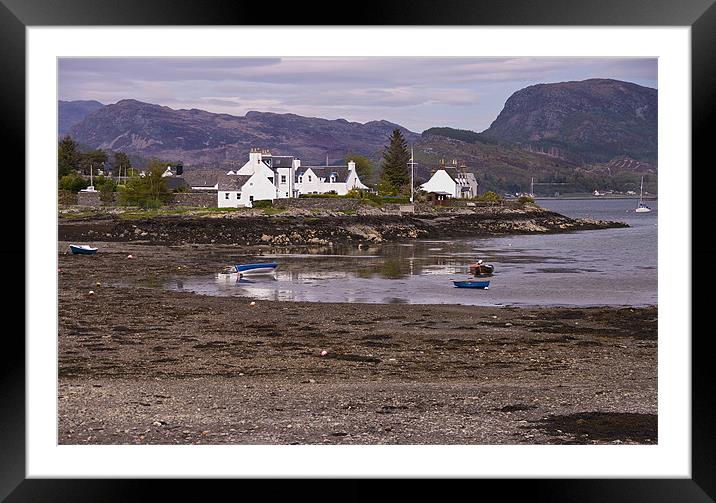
[165,199,658,306]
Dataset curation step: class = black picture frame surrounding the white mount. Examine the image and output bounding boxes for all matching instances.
[0,0,716,503]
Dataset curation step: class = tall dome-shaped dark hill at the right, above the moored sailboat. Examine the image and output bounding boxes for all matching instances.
[482,79,658,163]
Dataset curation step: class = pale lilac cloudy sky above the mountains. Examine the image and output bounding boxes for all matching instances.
[58,57,657,133]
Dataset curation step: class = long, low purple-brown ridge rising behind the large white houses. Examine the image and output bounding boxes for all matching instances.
[70,100,418,164]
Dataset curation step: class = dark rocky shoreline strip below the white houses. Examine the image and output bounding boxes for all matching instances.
[58,207,627,246]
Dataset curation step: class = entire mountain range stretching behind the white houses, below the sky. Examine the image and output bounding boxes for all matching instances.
[58,79,657,195]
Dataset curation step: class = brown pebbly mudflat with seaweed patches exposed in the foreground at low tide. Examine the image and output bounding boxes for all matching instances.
[58,241,657,444]
